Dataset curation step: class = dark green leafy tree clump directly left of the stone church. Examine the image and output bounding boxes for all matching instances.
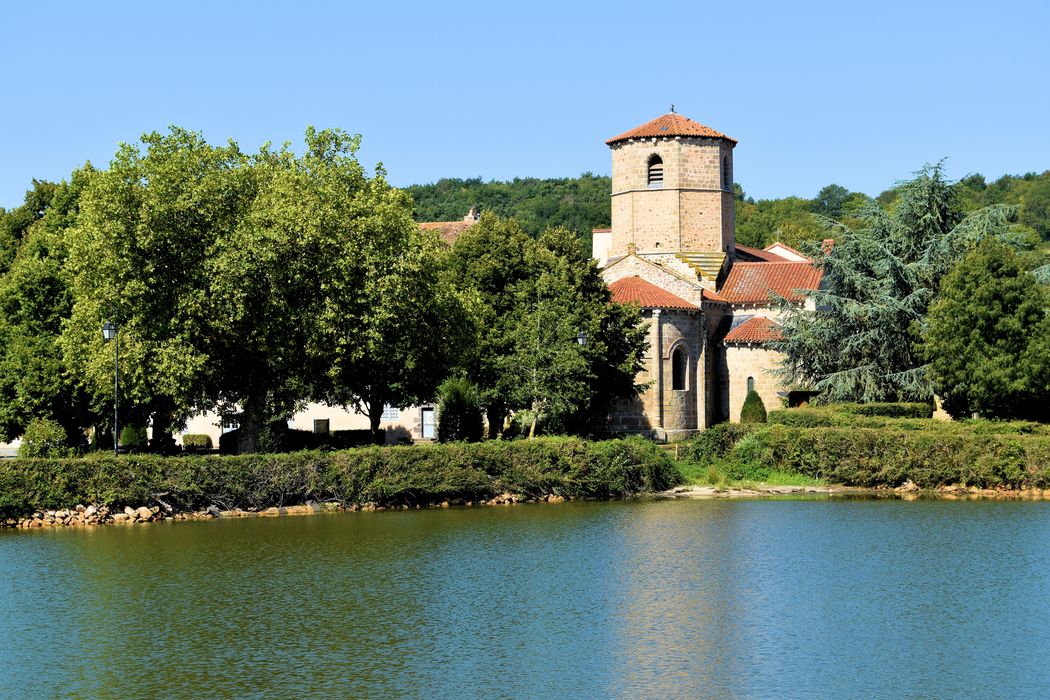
[449,214,646,433]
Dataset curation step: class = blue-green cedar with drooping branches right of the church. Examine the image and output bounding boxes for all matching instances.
[773,165,1010,401]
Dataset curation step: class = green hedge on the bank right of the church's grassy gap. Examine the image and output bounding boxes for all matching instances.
[683,408,1050,489]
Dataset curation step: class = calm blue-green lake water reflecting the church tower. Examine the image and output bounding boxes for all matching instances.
[0,500,1050,698]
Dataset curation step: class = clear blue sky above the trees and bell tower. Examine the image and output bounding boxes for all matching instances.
[0,0,1050,207]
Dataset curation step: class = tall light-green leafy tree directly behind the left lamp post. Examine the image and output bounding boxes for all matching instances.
[61,127,252,447]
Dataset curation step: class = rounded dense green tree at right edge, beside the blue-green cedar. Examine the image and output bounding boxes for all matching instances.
[923,239,1050,421]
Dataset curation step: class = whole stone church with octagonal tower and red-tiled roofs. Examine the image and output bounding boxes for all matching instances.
[593,110,821,440]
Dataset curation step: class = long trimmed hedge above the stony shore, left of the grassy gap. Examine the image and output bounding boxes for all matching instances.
[0,438,681,517]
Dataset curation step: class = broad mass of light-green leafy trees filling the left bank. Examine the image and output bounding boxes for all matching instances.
[15,128,473,451]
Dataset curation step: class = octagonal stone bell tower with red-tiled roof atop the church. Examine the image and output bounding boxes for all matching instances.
[606,110,736,270]
